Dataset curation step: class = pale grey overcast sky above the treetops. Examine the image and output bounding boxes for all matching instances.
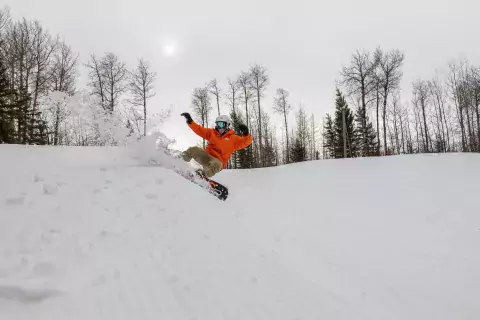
[6,0,480,149]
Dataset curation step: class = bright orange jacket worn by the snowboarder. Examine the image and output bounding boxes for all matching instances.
[188,121,252,169]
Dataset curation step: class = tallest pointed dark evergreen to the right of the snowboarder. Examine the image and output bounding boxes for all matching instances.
[333,89,358,158]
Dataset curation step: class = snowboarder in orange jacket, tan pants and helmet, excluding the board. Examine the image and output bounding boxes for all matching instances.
[181,112,252,178]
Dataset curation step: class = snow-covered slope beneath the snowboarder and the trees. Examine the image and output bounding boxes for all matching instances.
[0,145,480,320]
